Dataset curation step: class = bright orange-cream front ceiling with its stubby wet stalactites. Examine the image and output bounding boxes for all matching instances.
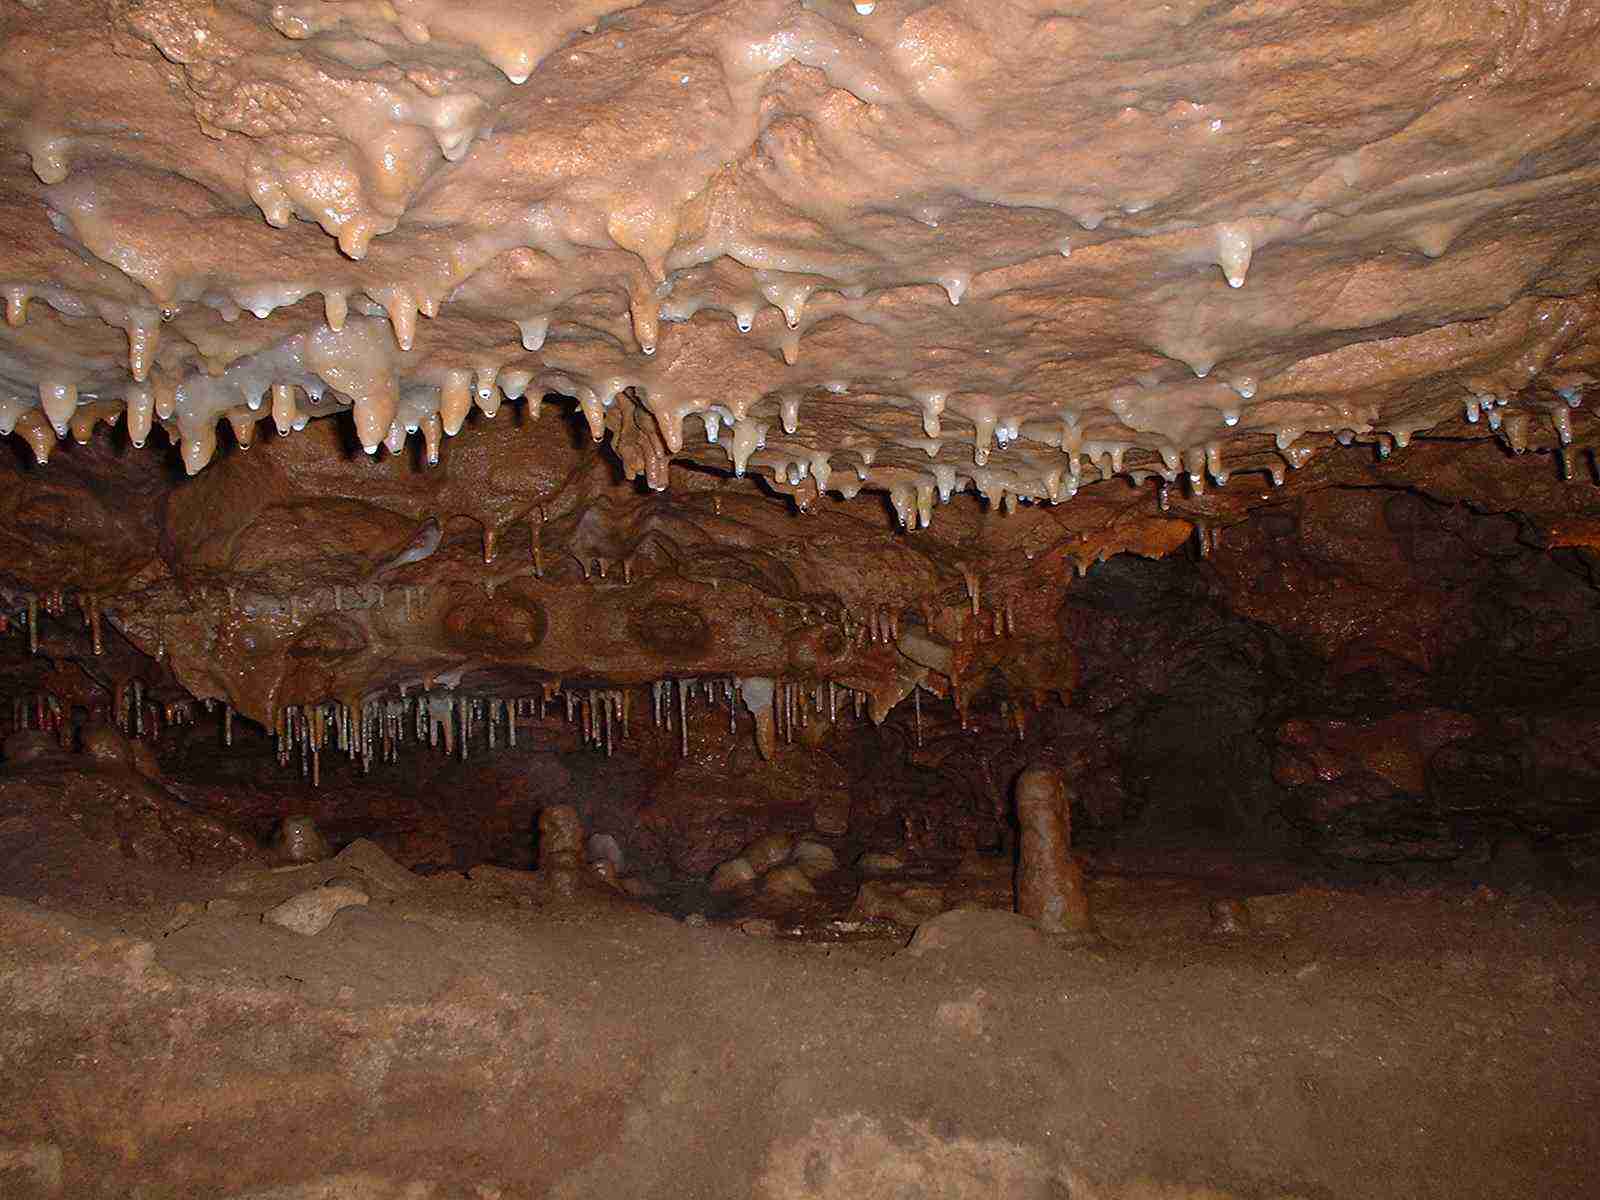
[0,0,1600,528]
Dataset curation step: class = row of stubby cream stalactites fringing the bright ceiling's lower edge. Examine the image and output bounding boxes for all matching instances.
[0,289,1582,530]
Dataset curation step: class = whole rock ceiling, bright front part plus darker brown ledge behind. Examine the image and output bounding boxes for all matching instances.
[0,0,1600,778]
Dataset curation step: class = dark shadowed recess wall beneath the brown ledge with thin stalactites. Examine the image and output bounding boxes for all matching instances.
[9,488,1600,878]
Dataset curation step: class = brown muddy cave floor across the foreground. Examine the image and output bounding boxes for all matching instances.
[0,762,1600,1200]
